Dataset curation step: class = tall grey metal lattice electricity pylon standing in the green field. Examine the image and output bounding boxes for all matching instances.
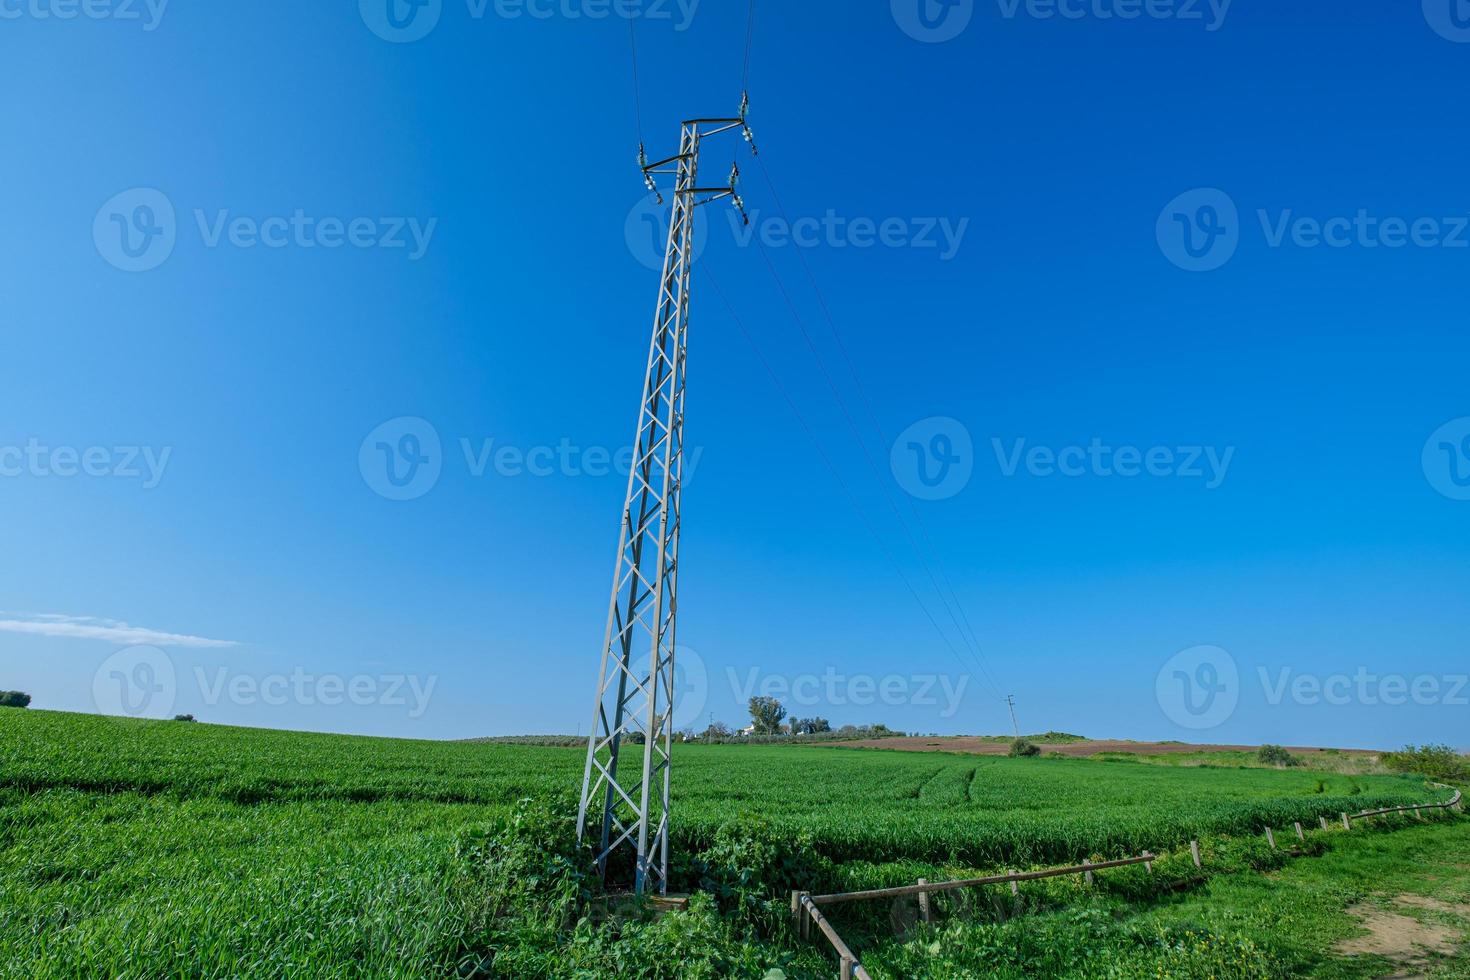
[576,98,756,893]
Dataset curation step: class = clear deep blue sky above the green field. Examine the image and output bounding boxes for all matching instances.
[0,0,1470,748]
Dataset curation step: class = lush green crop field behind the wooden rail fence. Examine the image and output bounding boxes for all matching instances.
[0,711,1458,977]
